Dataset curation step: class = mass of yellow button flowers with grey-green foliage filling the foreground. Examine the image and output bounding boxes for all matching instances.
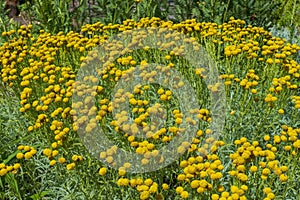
[0,0,300,200]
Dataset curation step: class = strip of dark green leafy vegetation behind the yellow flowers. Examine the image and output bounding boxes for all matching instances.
[0,0,300,34]
